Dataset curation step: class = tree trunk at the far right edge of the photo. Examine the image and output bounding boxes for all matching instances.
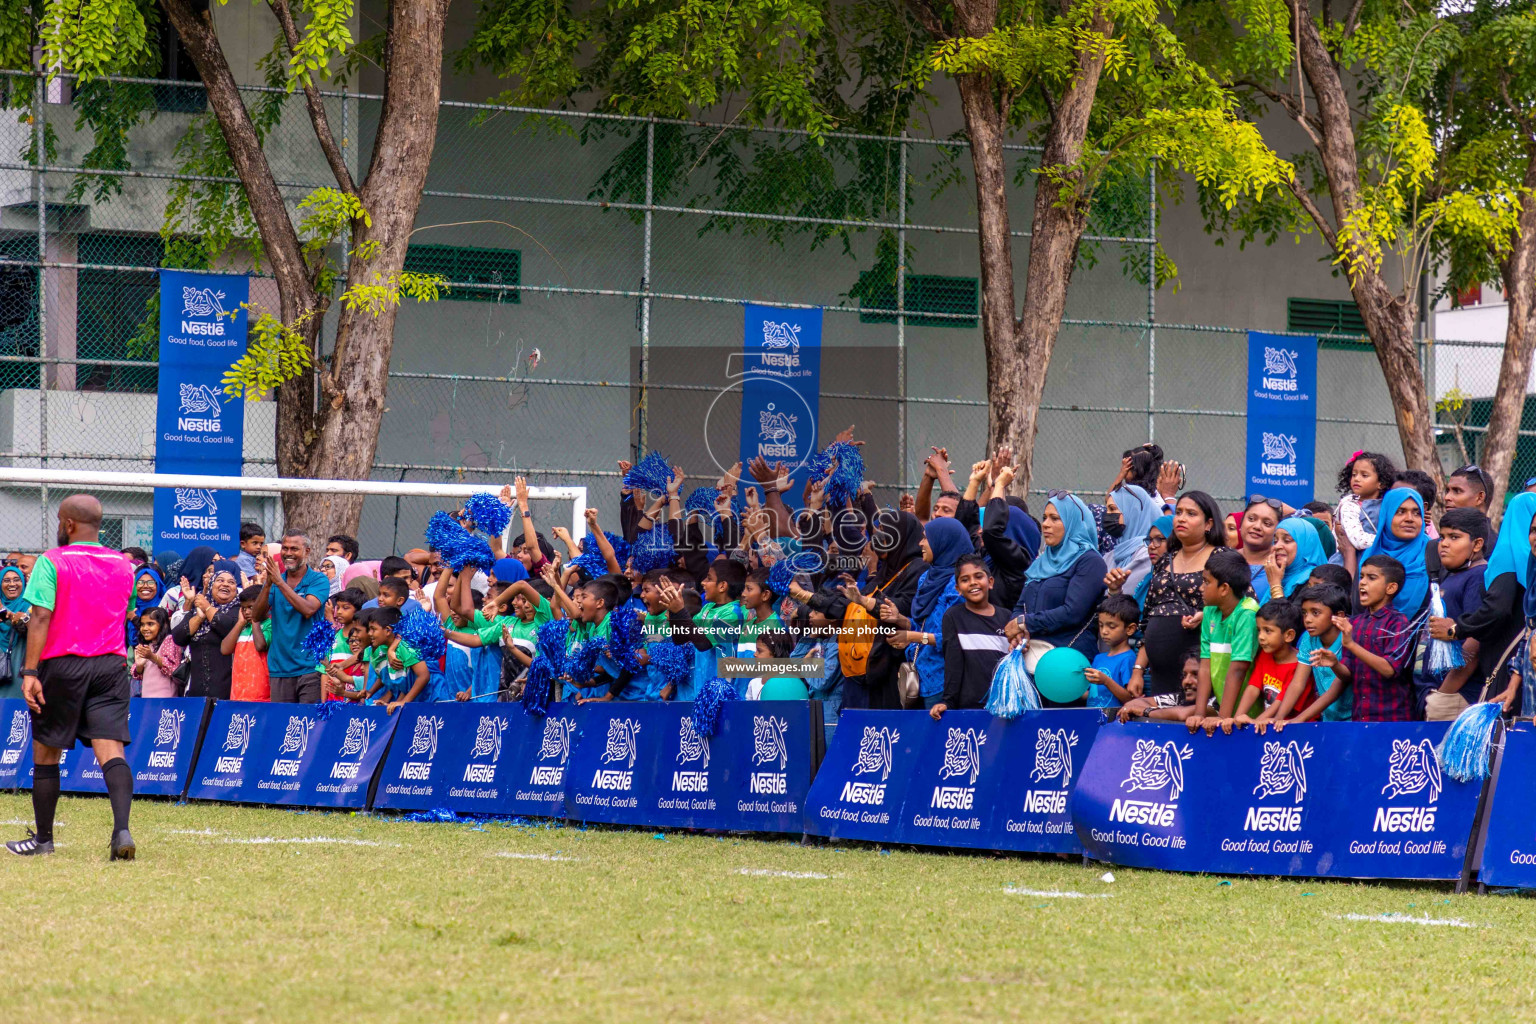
[1479,143,1536,524]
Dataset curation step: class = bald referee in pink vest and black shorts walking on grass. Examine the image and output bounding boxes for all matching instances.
[5,494,134,860]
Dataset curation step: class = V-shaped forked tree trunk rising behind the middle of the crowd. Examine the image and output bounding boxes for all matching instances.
[955,7,1112,496]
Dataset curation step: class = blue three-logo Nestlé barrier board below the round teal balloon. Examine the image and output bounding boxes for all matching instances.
[805,709,1104,854]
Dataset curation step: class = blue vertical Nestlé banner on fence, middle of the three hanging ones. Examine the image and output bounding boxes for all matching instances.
[740,302,822,493]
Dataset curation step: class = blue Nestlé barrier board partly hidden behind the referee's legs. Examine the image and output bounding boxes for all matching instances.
[58,697,209,797]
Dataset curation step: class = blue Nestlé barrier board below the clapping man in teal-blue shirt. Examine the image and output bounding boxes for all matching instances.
[187,700,399,808]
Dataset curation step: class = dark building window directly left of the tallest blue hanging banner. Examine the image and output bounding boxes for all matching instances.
[75,232,164,395]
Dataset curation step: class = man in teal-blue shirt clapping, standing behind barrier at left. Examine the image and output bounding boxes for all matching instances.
[253,533,330,705]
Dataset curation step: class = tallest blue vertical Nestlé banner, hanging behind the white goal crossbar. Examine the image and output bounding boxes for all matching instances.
[155,270,250,553]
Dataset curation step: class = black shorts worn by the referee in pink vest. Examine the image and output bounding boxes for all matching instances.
[32,654,134,751]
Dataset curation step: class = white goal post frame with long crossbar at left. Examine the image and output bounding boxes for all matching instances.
[0,467,587,537]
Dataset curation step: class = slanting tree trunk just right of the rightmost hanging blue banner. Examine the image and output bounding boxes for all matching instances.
[1290,0,1445,493]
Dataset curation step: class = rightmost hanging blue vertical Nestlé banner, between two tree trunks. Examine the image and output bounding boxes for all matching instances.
[1244,330,1318,508]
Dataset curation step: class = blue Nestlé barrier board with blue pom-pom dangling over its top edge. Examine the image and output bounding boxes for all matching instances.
[565,700,820,832]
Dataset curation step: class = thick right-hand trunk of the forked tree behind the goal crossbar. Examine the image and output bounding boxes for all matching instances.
[278,0,449,540]
